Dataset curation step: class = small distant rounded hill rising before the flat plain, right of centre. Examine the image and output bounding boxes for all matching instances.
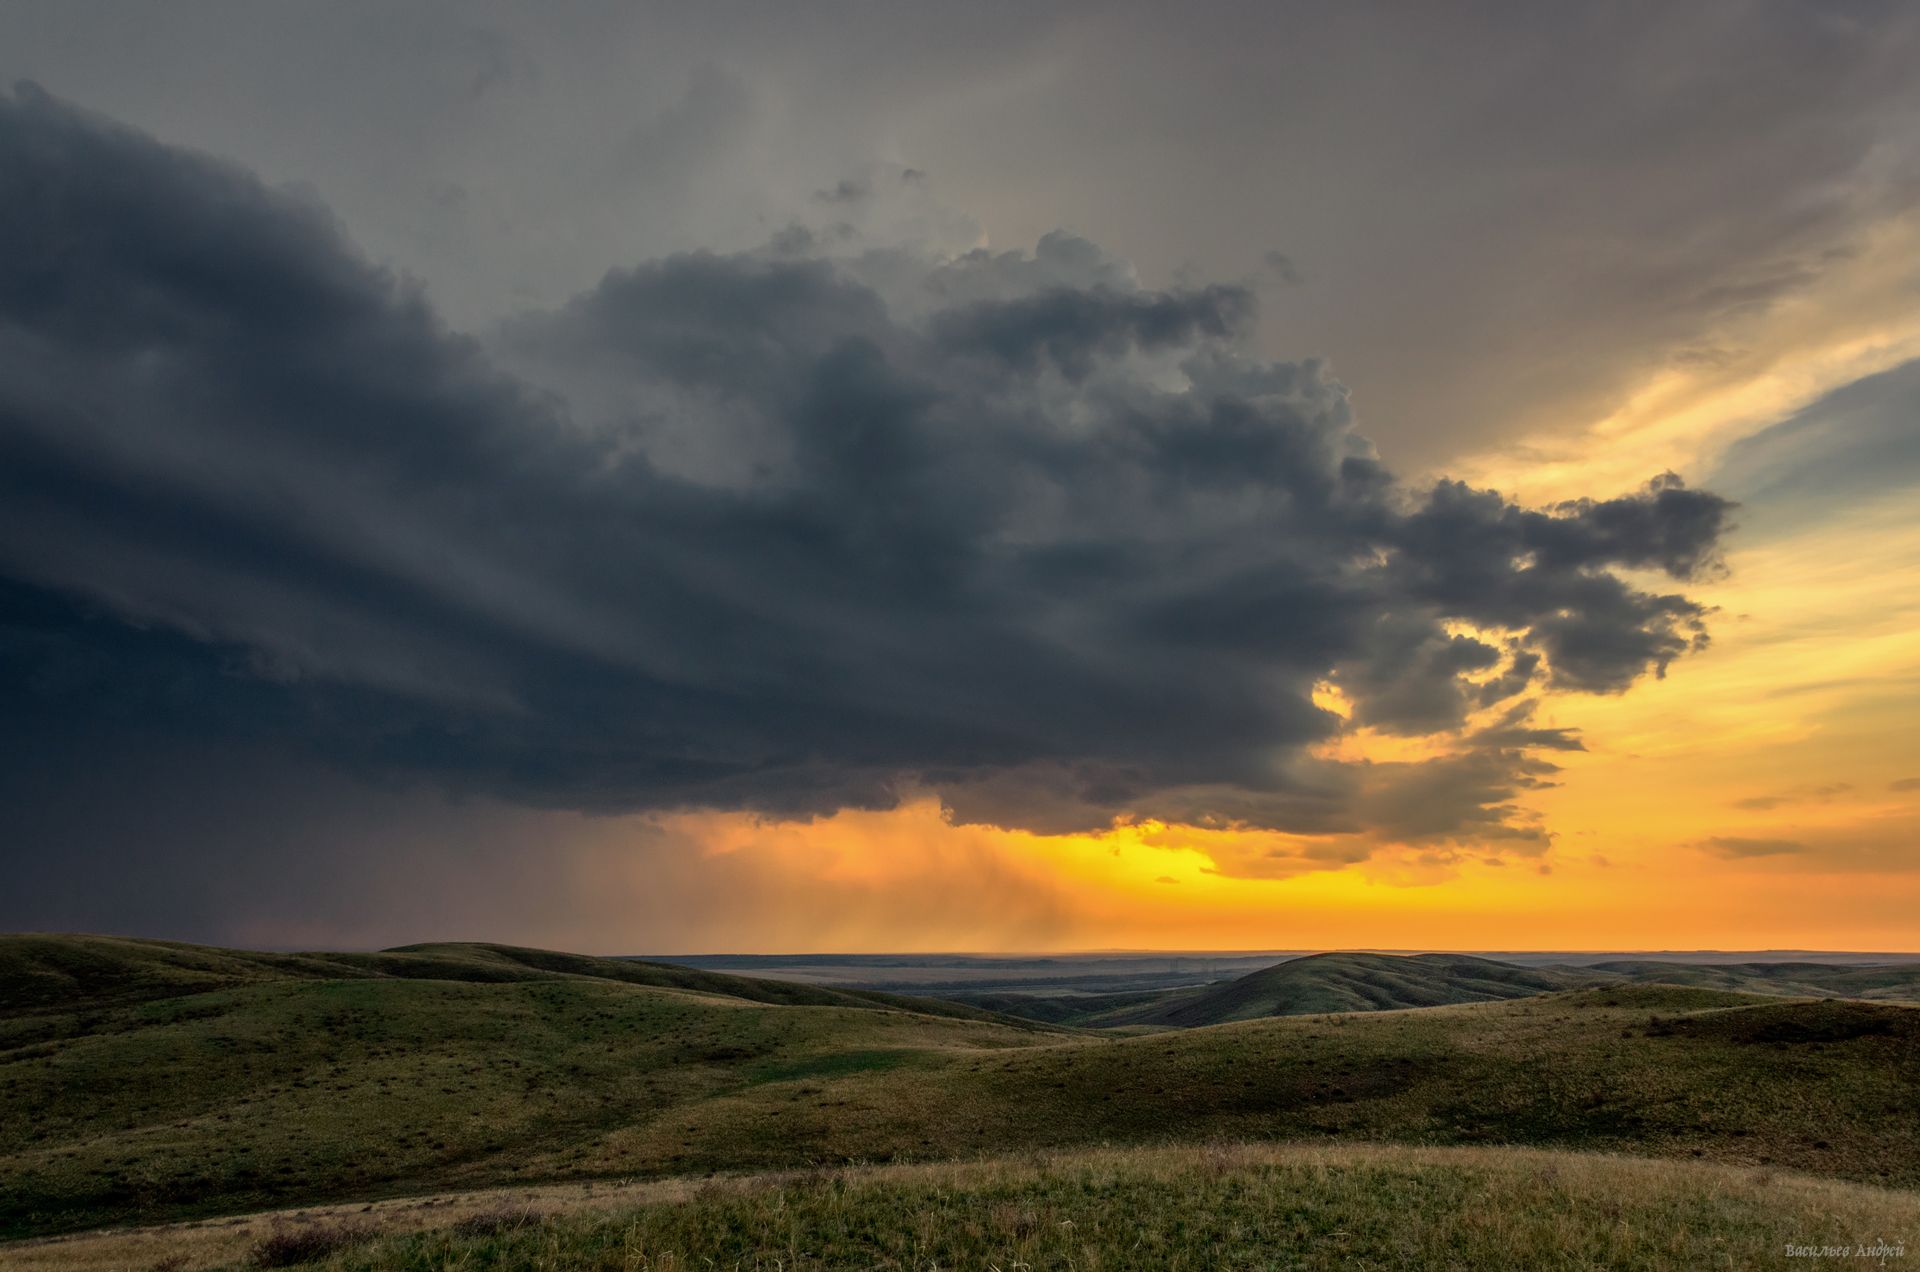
[1085,953,1601,1028]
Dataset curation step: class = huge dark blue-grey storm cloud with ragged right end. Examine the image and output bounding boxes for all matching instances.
[0,88,1728,855]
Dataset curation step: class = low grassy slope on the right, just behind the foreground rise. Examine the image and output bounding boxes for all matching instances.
[580,986,1920,1187]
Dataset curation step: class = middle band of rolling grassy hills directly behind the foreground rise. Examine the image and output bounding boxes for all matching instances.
[0,938,1920,1262]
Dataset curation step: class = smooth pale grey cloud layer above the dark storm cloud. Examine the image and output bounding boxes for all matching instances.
[0,0,1920,471]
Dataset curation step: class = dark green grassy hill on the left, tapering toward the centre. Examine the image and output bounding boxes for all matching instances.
[0,938,1037,1235]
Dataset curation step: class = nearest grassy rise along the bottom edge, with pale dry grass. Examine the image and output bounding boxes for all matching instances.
[12,1145,1920,1272]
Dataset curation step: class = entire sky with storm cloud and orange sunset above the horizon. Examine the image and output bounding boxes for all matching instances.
[0,0,1920,953]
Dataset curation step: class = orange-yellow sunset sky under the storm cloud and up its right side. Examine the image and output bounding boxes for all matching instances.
[618,503,1920,953]
